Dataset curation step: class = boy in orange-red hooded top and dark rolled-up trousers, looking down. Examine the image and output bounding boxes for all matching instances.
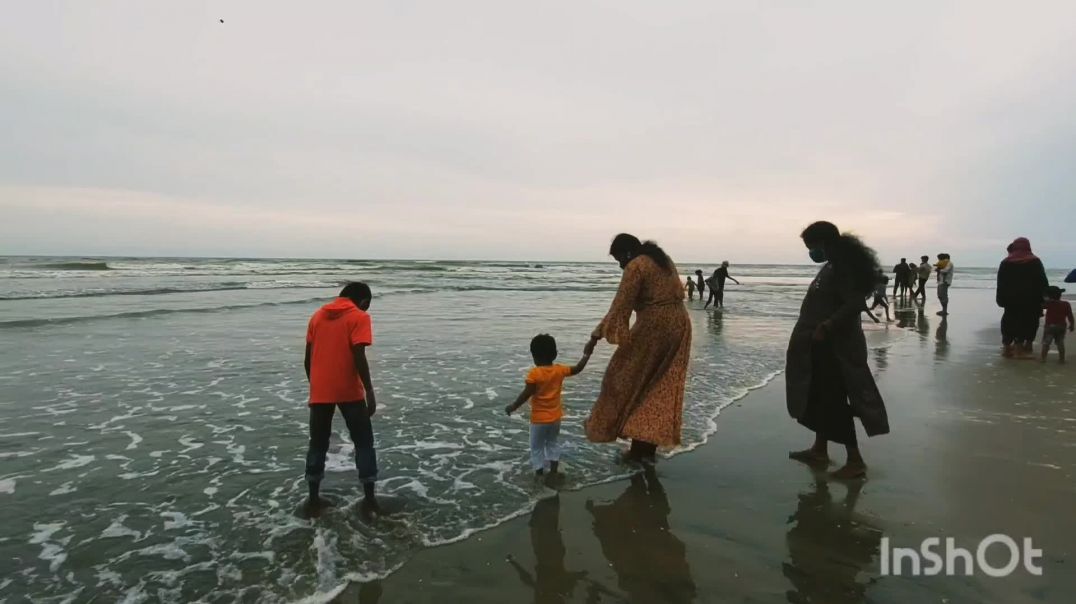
[303,283,378,516]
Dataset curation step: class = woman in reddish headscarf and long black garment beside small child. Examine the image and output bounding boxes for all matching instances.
[996,237,1050,356]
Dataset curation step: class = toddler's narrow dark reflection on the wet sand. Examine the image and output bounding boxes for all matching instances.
[508,495,586,603]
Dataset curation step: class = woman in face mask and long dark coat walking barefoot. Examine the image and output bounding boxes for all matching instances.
[785,222,889,479]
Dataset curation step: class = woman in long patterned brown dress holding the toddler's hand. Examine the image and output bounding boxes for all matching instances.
[585,234,691,461]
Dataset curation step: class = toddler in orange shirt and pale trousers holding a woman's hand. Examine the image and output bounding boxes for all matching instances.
[505,334,596,476]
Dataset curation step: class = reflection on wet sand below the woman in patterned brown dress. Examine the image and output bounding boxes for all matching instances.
[586,466,696,603]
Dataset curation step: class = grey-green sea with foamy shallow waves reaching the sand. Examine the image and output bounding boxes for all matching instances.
[0,257,1063,602]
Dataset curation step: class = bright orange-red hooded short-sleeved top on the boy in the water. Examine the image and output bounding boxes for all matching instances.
[307,298,373,405]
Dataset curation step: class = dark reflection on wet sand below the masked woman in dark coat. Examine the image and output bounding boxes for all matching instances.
[782,477,881,604]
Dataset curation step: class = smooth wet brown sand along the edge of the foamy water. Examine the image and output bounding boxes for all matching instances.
[337,291,1076,603]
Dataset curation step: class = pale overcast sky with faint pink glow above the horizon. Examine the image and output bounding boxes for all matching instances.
[0,0,1076,268]
